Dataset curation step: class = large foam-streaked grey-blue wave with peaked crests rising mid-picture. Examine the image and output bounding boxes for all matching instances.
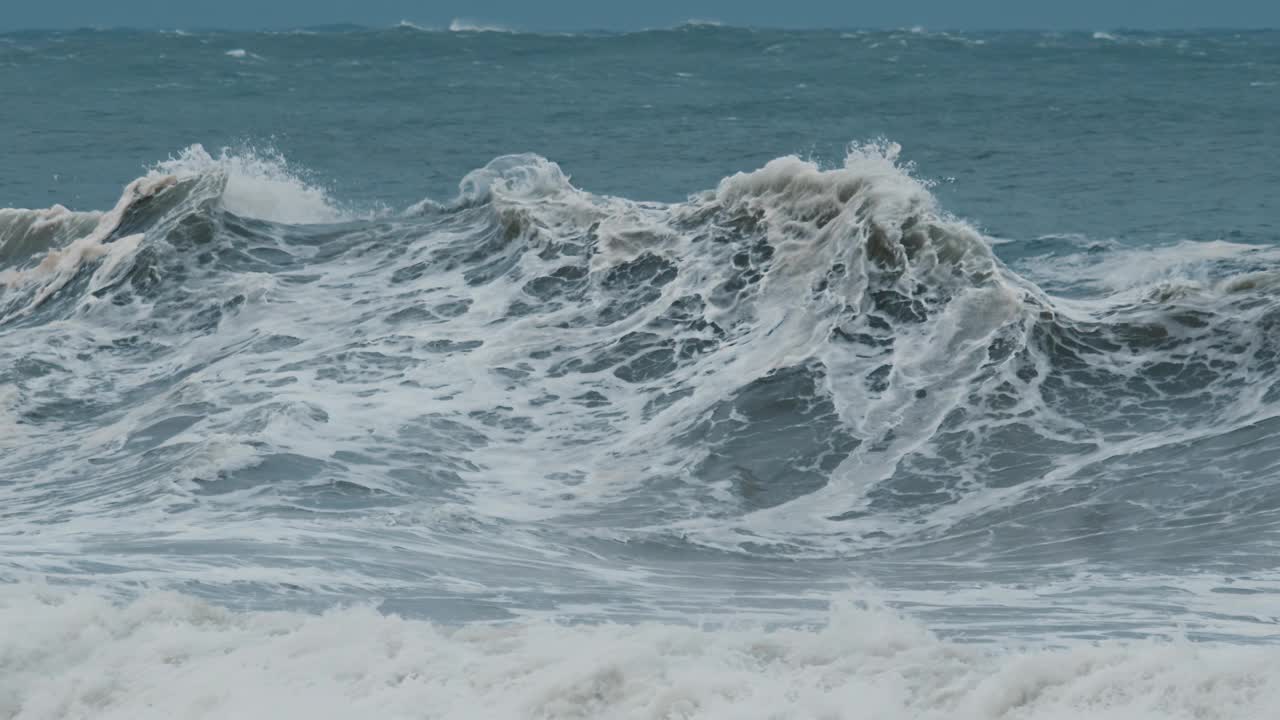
[0,140,1280,582]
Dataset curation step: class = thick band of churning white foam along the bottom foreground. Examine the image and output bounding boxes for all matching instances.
[0,585,1280,720]
